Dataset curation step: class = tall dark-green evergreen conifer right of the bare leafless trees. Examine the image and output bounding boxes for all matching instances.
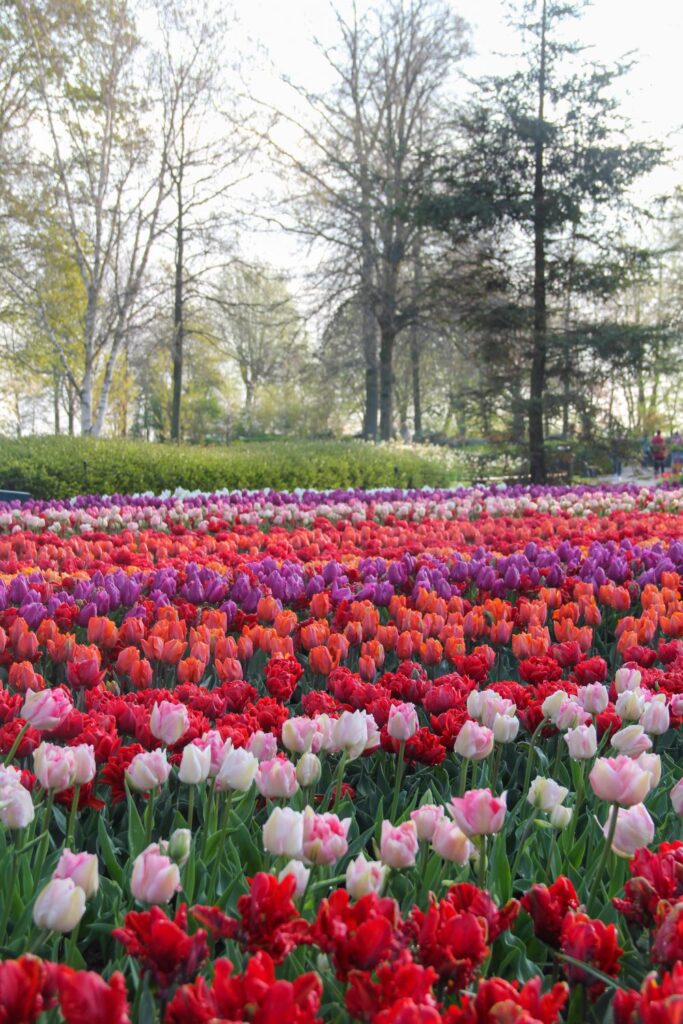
[423,0,661,481]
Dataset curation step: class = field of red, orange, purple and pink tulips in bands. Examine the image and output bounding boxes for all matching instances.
[0,485,683,1024]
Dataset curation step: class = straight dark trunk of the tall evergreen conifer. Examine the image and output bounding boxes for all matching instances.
[528,0,548,483]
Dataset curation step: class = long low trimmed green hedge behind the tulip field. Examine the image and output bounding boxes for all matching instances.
[0,436,454,498]
